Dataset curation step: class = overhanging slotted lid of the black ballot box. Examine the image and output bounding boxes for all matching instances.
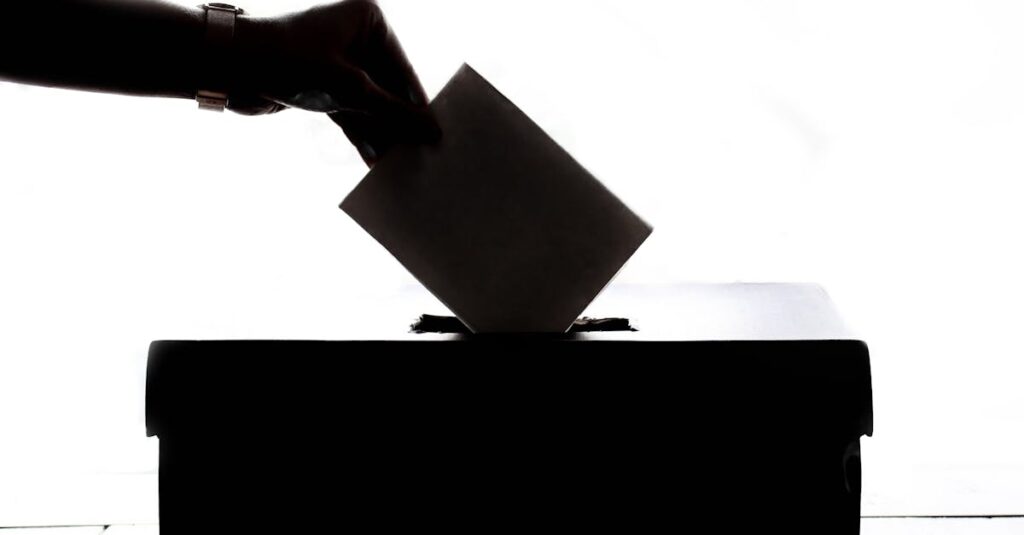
[146,284,872,436]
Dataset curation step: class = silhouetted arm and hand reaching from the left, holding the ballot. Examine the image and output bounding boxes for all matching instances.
[0,0,440,165]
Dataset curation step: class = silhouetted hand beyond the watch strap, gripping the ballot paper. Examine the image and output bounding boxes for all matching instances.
[228,0,440,165]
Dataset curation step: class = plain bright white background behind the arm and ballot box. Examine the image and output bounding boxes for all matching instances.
[0,0,1024,520]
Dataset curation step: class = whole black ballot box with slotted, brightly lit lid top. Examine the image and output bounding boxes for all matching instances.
[146,284,871,535]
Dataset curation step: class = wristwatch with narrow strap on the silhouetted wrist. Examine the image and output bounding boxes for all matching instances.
[196,3,245,112]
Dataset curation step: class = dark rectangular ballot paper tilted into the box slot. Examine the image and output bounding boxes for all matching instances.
[341,61,651,327]
